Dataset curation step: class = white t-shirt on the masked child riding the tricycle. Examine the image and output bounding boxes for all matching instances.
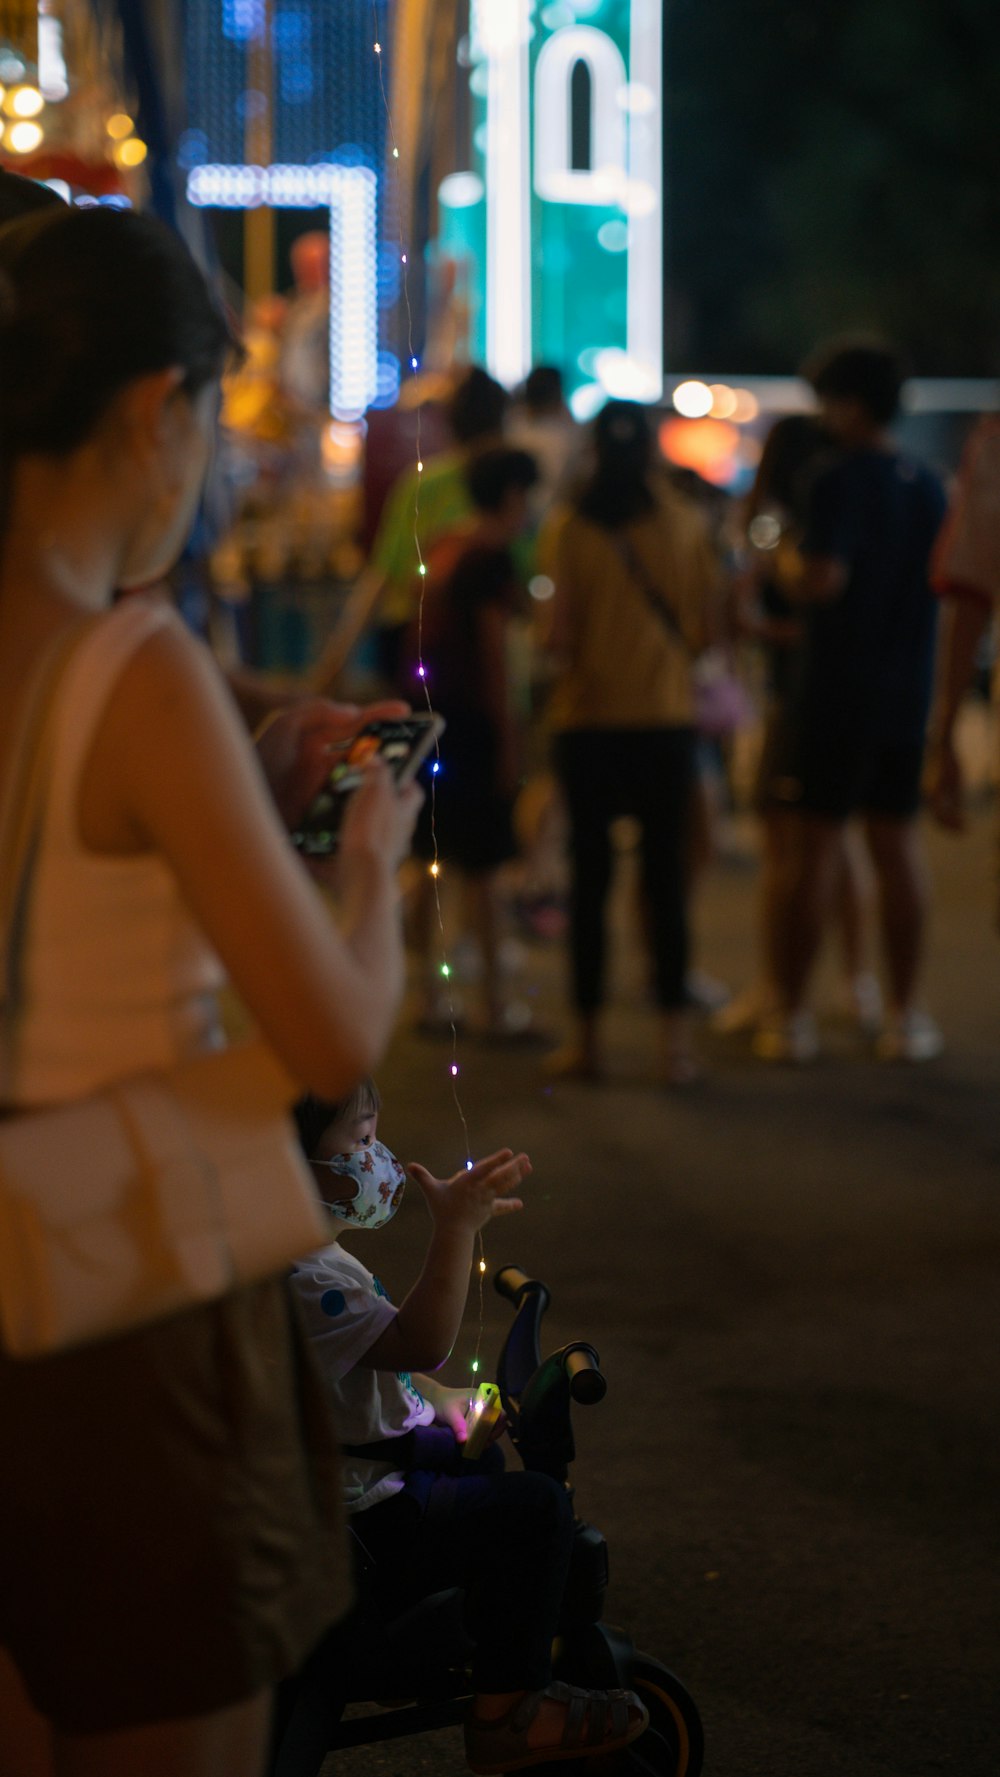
[291,1242,433,1512]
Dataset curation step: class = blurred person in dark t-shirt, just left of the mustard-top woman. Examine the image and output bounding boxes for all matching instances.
[409,446,538,1036]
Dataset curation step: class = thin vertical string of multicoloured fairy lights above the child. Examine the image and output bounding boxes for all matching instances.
[371,0,487,1375]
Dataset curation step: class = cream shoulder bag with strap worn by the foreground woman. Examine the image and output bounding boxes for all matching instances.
[0,618,329,1358]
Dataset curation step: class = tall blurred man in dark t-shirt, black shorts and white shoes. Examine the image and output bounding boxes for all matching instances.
[755,341,945,1061]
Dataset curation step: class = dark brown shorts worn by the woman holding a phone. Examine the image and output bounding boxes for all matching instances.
[0,1279,352,1733]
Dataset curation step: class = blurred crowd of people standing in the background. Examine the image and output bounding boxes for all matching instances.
[213,339,996,1084]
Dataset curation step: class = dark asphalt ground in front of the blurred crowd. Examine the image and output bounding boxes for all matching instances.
[316,817,1000,1777]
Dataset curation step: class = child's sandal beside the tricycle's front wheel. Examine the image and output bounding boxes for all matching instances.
[465,1683,650,1777]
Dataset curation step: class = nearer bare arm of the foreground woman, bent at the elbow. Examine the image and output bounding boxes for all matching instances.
[80,622,419,1098]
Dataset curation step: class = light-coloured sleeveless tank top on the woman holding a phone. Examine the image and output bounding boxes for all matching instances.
[5,595,224,1105]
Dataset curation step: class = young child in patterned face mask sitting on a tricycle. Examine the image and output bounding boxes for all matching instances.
[293,1080,647,1777]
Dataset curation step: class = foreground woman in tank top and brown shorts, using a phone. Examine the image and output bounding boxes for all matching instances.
[0,210,419,1777]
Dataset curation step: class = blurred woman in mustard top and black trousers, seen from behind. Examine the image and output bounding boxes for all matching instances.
[549,402,718,1086]
